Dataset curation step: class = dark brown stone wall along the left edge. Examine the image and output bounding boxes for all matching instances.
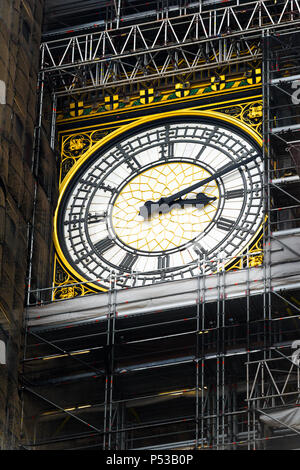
[0,0,57,449]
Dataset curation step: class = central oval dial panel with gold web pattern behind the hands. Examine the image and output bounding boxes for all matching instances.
[112,161,219,254]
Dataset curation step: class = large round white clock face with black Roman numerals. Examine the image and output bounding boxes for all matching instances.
[55,112,263,288]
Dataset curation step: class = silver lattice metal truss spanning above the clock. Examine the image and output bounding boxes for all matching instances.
[41,0,300,96]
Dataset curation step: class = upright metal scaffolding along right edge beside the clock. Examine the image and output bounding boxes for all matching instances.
[246,26,300,449]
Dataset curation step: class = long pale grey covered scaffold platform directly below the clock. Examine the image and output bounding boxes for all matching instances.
[27,234,300,327]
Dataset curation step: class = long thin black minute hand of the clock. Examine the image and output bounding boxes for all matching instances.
[140,154,258,214]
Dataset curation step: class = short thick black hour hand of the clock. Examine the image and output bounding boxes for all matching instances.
[139,193,217,219]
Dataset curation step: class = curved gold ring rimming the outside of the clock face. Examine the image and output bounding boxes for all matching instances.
[53,109,262,291]
